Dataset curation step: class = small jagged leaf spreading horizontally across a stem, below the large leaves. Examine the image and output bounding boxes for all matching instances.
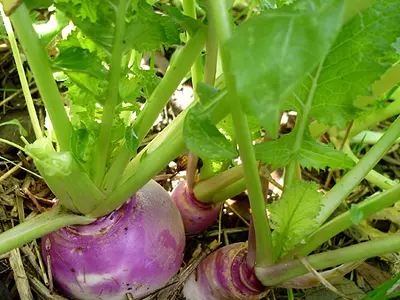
[255,132,354,170]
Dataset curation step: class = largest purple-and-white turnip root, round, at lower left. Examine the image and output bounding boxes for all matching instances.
[42,181,185,300]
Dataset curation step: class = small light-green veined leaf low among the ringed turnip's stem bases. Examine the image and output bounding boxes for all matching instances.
[268,181,322,258]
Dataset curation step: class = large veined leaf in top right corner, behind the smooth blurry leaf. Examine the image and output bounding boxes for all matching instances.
[288,0,400,128]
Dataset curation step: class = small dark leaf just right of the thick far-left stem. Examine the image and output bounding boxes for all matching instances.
[51,47,107,80]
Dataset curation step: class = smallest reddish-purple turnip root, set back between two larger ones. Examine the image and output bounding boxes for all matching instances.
[171,181,221,234]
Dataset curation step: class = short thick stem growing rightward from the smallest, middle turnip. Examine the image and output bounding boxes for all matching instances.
[193,165,244,203]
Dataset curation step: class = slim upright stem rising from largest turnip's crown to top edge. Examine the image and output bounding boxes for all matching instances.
[92,0,126,186]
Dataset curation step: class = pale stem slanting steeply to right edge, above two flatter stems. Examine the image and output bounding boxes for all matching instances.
[317,117,400,224]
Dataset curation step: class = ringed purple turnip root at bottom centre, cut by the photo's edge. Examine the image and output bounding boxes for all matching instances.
[183,243,266,300]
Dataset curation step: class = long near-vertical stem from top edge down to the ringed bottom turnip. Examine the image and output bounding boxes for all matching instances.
[208,0,273,266]
